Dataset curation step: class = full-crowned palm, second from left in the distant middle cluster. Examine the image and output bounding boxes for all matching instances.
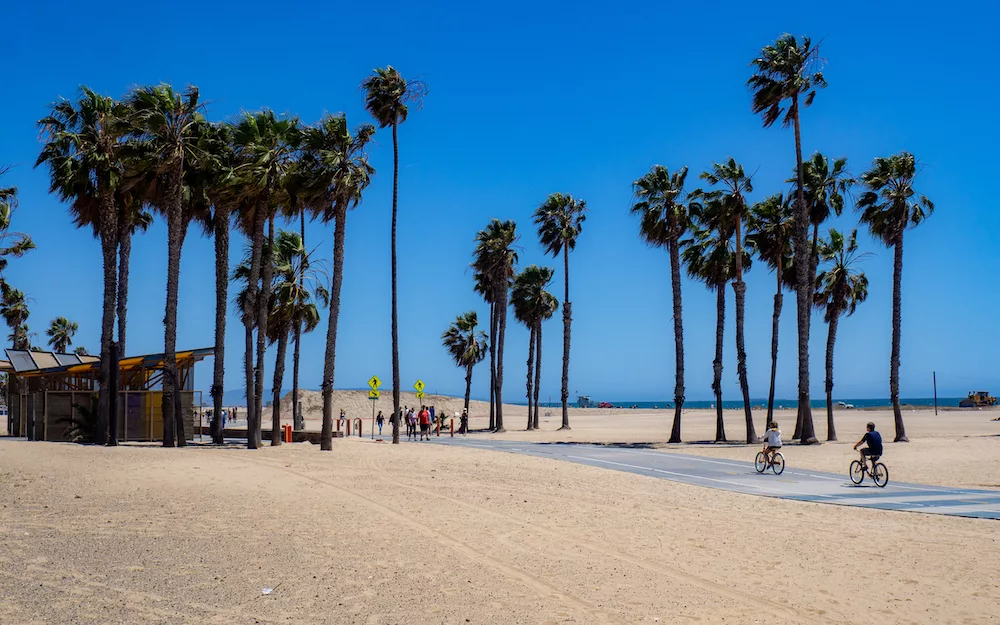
[472,219,518,432]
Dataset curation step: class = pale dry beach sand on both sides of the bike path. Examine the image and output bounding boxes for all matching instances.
[0,402,1000,624]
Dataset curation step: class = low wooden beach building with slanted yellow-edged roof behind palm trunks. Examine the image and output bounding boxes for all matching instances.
[0,347,215,441]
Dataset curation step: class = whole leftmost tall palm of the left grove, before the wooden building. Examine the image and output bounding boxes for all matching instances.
[35,87,128,442]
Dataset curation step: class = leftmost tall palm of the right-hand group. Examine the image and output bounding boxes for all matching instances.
[631,165,688,443]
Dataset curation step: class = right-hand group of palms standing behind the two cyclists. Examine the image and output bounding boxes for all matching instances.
[631,35,934,443]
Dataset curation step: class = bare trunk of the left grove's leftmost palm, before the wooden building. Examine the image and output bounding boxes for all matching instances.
[96,193,118,444]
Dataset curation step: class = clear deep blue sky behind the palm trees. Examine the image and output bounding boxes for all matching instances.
[0,0,1000,400]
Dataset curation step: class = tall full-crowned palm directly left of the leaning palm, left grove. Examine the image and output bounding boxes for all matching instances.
[232,110,301,449]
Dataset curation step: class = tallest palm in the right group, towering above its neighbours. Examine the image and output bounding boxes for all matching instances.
[747,34,826,444]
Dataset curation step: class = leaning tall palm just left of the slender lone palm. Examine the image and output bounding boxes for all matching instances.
[293,115,376,451]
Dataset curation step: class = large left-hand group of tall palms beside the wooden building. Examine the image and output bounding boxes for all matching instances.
[37,67,424,450]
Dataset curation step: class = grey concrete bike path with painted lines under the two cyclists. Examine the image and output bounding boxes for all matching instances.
[431,436,1000,519]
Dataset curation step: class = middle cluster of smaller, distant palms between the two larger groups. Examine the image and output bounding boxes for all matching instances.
[441,193,587,432]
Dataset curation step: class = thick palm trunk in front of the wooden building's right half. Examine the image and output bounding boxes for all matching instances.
[162,173,187,447]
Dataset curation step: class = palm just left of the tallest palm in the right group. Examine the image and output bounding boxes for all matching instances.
[747,193,795,423]
